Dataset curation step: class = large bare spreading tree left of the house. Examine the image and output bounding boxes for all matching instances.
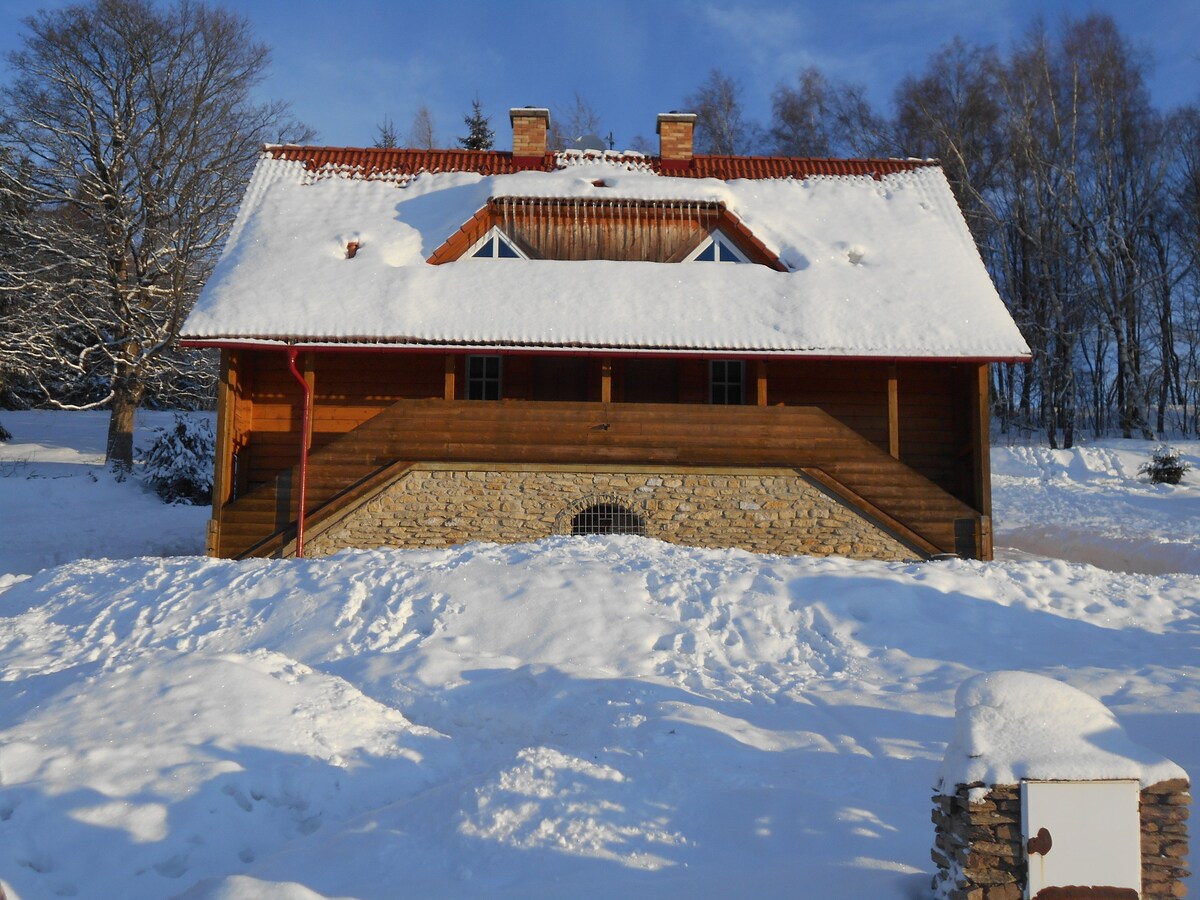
[0,0,307,468]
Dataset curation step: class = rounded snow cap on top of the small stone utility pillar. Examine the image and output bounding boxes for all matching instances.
[937,672,1187,792]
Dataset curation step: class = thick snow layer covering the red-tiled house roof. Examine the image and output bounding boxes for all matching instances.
[184,152,1028,359]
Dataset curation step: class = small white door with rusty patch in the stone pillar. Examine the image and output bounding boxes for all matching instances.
[1021,781,1141,900]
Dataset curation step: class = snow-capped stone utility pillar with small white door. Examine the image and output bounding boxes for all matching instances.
[931,672,1192,900]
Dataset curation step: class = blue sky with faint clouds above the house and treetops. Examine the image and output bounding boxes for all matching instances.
[0,0,1200,149]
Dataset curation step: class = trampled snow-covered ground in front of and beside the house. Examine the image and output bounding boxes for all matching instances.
[0,413,1200,900]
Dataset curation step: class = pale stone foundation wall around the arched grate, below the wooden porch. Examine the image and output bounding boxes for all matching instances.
[306,463,918,559]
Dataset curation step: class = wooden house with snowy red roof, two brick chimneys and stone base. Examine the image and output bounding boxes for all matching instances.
[184,108,1028,559]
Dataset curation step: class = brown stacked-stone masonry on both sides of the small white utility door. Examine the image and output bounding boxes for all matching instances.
[931,779,1192,900]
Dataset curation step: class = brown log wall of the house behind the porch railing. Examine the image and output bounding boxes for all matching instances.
[217,350,990,525]
